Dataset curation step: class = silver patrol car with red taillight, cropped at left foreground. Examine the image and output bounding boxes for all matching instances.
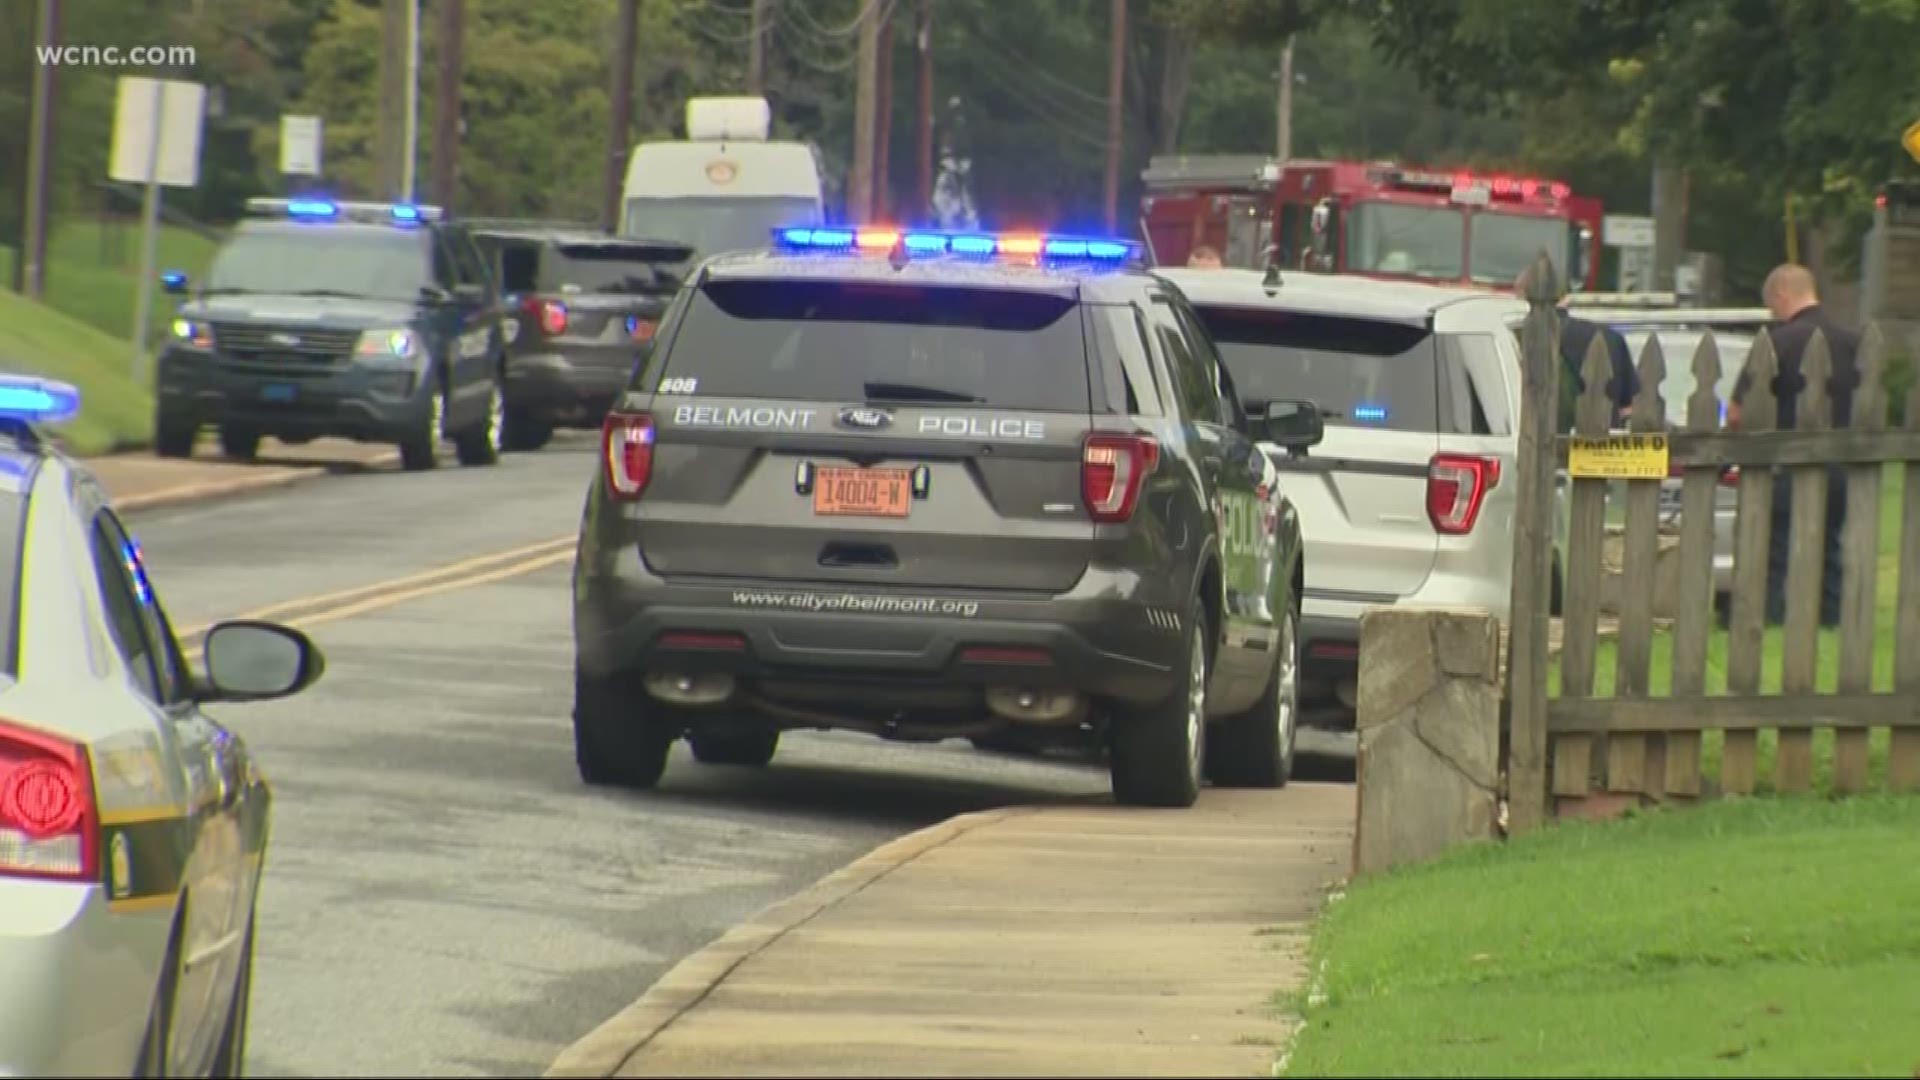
[0,375,324,1076]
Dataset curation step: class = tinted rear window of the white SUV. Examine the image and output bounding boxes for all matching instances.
[1196,307,1440,430]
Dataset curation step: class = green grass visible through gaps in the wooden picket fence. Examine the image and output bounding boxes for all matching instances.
[1548,465,1905,792]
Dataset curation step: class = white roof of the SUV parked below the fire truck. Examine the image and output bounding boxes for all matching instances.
[1154,267,1524,325]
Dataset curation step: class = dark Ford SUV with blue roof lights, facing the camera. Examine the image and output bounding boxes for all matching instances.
[154,198,505,469]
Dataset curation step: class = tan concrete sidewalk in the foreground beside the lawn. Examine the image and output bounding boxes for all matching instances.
[547,784,1356,1076]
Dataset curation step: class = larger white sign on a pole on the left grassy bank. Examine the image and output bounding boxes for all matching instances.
[108,77,207,380]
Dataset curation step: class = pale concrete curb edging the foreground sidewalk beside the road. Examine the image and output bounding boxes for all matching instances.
[541,807,1039,1078]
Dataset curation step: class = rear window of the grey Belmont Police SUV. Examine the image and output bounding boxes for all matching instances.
[660,281,1089,413]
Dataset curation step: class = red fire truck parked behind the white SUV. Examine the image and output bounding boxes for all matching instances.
[1140,156,1601,290]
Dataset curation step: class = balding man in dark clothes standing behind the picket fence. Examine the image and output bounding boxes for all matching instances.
[1726,263,1860,626]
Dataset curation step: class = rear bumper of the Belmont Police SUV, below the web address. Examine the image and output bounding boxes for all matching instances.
[574,550,1185,707]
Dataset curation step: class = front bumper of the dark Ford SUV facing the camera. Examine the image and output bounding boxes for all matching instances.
[156,348,432,442]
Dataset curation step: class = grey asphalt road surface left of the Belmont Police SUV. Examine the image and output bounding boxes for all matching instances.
[129,438,1152,1076]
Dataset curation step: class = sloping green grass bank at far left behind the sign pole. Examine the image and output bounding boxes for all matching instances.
[0,221,213,454]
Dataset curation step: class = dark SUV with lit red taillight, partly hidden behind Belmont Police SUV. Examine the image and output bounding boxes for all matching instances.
[468,221,693,450]
